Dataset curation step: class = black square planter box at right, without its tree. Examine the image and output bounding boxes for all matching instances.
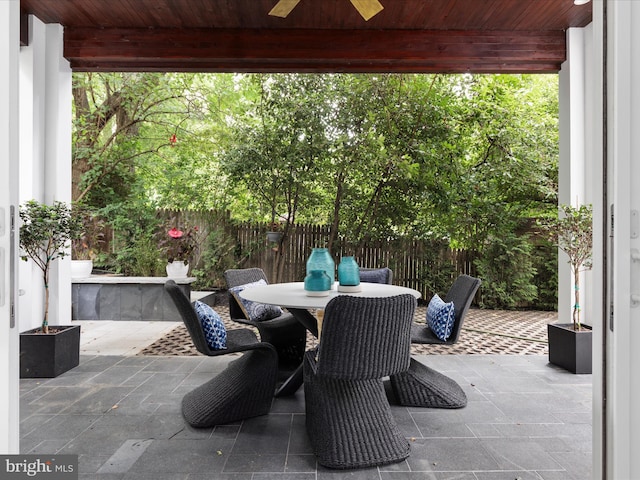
[547,323,592,373]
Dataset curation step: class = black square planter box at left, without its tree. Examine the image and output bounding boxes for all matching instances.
[20,325,80,378]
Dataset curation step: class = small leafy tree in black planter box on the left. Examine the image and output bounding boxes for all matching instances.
[20,200,82,378]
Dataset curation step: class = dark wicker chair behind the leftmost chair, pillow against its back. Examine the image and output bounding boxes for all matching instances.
[224,268,307,370]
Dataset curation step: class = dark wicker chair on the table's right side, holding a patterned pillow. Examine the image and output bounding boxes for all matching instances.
[390,275,480,408]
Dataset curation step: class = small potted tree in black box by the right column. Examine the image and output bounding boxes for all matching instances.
[544,205,593,373]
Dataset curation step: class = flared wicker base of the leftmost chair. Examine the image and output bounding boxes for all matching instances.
[182,349,277,428]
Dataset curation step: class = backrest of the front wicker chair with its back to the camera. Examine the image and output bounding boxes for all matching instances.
[318,294,417,380]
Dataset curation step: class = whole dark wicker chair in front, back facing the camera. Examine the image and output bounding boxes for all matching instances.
[304,294,416,469]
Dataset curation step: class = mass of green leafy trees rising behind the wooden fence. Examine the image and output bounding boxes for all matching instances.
[74,73,558,305]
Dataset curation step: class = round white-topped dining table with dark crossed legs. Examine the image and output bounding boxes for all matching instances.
[240,282,421,397]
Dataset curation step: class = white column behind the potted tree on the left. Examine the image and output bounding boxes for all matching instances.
[19,17,72,331]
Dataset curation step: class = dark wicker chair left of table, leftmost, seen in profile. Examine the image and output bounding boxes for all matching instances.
[164,280,278,427]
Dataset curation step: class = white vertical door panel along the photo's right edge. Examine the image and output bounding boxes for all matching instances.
[594,0,640,480]
